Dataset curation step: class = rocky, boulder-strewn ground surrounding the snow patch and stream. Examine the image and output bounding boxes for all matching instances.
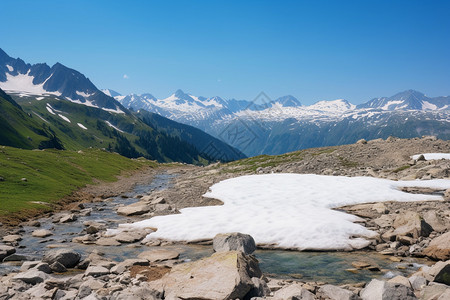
[0,137,450,300]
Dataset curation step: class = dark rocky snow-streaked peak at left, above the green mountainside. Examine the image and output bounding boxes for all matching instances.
[0,49,126,113]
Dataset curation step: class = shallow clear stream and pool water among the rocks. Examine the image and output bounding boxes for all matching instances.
[0,174,432,284]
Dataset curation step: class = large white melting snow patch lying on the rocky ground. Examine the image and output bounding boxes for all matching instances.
[120,174,450,250]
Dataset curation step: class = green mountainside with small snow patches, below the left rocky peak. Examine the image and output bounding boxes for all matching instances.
[8,95,209,164]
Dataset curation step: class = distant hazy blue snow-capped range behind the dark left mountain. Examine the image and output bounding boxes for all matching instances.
[115,90,450,156]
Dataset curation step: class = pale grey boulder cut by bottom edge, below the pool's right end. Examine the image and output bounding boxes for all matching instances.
[360,279,417,300]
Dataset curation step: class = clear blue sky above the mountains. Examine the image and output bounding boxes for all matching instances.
[0,0,450,104]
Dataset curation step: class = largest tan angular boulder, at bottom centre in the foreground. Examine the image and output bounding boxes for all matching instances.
[150,251,262,299]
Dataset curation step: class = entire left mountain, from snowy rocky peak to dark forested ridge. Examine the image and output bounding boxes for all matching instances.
[0,49,245,164]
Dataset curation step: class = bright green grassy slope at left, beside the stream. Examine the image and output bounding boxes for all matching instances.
[0,146,157,216]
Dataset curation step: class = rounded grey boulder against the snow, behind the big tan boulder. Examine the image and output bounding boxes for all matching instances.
[213,232,256,254]
